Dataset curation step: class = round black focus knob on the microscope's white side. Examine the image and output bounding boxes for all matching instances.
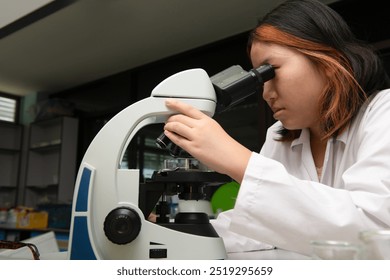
[104,207,141,245]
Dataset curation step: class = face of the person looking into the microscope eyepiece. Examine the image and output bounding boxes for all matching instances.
[250,41,326,135]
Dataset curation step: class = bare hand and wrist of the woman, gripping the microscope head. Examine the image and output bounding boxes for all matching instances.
[164,99,251,183]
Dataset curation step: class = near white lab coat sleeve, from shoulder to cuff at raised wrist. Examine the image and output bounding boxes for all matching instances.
[229,91,390,255]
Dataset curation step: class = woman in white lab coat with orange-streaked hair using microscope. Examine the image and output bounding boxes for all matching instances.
[165,0,390,254]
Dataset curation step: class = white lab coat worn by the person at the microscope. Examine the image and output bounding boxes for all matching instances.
[213,89,390,255]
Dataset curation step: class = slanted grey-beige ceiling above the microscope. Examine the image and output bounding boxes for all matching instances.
[0,0,335,96]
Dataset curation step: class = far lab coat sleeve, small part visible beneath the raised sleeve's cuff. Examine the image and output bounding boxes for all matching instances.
[210,210,274,253]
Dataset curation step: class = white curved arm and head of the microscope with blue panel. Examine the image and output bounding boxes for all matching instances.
[69,69,225,259]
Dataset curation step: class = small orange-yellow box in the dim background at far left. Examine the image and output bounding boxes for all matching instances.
[16,210,49,229]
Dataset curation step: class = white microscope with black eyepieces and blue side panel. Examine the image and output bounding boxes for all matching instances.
[68,64,275,260]
